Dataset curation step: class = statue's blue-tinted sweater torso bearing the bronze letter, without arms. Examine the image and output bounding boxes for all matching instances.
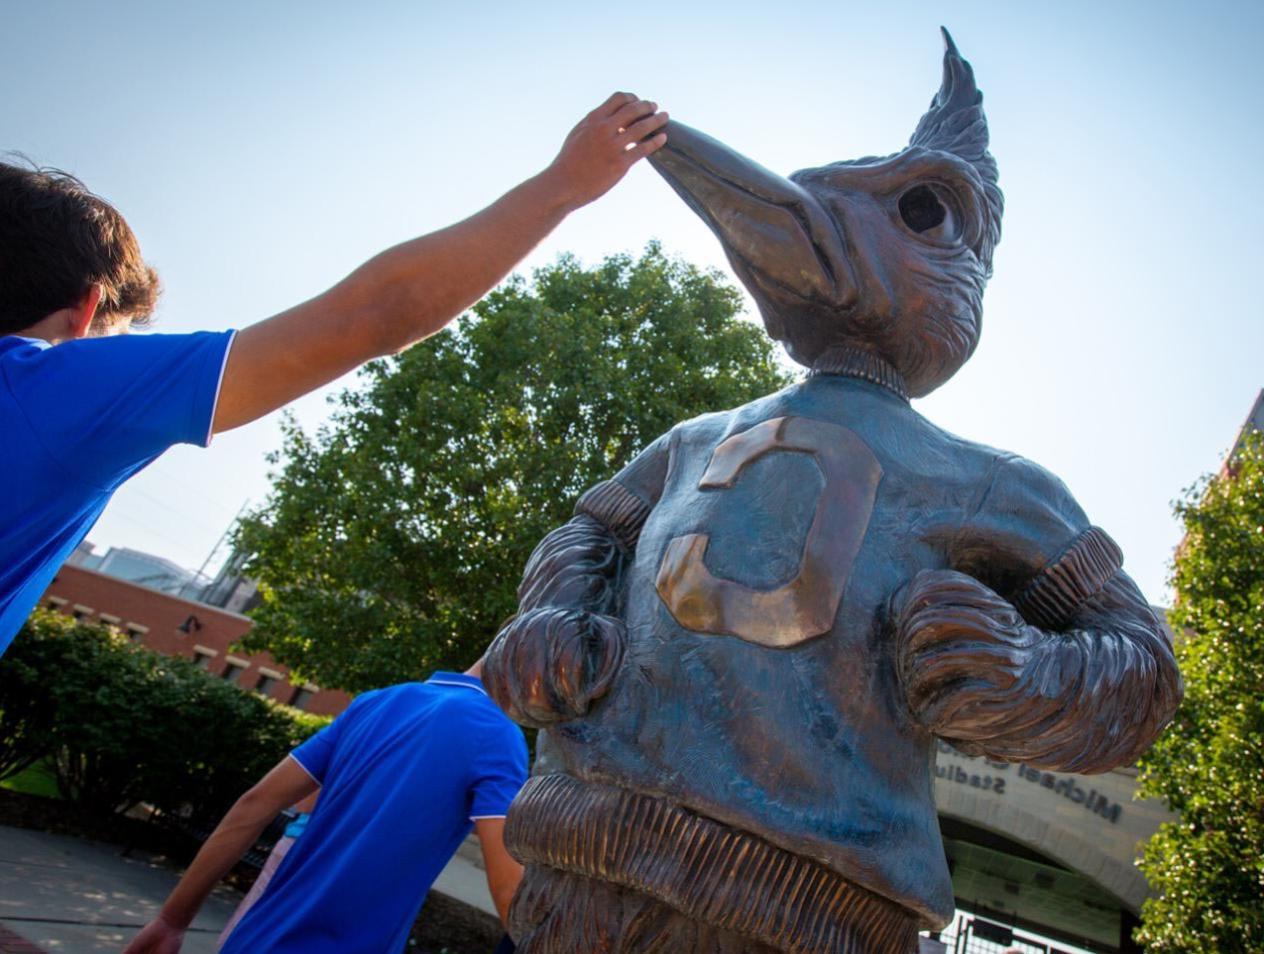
[544,378,996,920]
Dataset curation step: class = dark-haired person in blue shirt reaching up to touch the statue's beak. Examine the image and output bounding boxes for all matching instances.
[0,92,667,653]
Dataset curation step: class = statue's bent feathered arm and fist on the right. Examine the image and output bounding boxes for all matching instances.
[896,462,1182,772]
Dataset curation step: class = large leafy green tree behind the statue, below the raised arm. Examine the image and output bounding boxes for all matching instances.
[236,244,789,691]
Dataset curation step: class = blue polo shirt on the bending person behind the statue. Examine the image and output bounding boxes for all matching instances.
[221,672,527,954]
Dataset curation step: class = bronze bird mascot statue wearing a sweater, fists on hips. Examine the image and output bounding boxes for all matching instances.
[485,32,1182,954]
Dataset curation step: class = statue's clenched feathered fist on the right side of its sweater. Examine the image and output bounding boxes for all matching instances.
[894,570,1052,751]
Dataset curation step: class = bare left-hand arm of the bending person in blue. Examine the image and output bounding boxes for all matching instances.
[124,756,319,954]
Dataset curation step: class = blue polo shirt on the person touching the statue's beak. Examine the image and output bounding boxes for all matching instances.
[0,331,233,655]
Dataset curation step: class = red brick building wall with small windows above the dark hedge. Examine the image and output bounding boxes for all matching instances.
[40,565,351,715]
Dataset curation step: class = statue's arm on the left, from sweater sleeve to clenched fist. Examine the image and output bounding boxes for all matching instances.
[483,436,670,727]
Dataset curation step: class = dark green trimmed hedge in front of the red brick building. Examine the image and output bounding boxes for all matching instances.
[0,610,327,820]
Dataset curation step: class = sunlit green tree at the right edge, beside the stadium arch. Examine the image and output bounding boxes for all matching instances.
[1138,435,1264,954]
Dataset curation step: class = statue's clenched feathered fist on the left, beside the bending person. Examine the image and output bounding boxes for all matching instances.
[483,607,624,728]
